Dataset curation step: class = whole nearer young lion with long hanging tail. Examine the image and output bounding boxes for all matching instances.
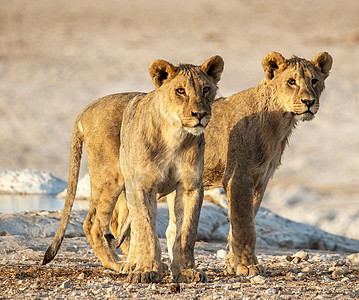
[43,56,223,282]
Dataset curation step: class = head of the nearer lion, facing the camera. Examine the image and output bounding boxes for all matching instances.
[150,56,224,135]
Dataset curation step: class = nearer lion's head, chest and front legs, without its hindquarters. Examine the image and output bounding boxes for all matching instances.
[120,56,223,282]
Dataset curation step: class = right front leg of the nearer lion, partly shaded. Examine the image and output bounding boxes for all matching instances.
[168,185,207,283]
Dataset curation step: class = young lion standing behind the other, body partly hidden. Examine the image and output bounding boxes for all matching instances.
[111,52,333,275]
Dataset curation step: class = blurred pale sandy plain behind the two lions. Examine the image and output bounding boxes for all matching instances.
[0,0,359,238]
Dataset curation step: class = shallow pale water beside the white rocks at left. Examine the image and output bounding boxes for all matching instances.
[0,194,89,213]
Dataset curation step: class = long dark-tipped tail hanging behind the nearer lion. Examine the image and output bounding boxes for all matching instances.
[42,115,84,265]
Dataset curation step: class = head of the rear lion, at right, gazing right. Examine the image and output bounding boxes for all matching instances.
[262,52,333,121]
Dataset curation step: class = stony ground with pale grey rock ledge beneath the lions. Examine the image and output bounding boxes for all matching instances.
[0,206,359,299]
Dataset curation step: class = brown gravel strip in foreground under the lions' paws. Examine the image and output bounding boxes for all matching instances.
[0,236,359,299]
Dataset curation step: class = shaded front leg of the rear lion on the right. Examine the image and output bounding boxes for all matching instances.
[226,175,264,276]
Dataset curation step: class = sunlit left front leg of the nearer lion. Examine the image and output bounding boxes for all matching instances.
[126,185,163,283]
